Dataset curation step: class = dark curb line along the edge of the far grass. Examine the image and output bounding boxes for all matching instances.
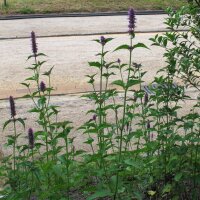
[0,10,166,20]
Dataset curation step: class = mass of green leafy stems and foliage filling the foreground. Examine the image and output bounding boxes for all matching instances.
[0,2,200,200]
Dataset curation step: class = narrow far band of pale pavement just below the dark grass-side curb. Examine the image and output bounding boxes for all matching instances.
[0,14,167,39]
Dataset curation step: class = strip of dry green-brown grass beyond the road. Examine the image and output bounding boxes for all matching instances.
[0,0,186,15]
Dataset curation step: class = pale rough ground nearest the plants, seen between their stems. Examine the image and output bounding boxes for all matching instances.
[0,86,200,154]
